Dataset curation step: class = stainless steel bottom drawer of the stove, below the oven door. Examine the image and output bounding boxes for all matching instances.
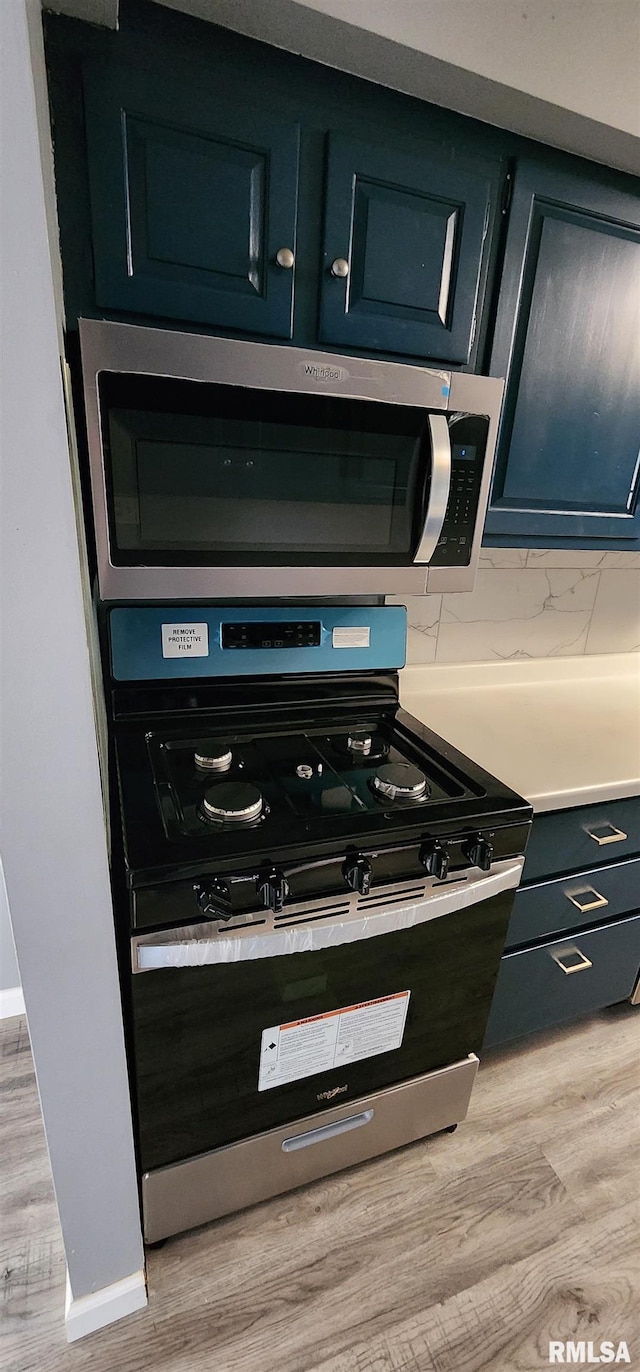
[143,1054,478,1243]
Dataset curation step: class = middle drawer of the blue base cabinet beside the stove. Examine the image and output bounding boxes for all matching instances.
[507,858,640,948]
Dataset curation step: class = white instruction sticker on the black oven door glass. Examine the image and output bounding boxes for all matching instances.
[258,991,411,1091]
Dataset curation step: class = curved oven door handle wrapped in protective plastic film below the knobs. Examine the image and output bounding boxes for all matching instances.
[132,858,525,973]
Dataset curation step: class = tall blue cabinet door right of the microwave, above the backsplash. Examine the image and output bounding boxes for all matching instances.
[485,165,640,549]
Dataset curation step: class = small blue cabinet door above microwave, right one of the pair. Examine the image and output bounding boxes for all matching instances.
[320,134,490,364]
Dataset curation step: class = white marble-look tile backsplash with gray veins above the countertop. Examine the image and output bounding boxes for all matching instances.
[389,547,640,663]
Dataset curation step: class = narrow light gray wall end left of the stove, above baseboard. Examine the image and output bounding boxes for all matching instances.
[0,0,143,1317]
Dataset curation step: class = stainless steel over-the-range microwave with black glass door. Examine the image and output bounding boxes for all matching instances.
[80,320,503,601]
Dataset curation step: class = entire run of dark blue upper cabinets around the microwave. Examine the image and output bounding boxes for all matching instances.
[45,0,640,550]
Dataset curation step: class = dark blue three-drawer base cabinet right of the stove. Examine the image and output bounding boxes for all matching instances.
[485,799,640,1047]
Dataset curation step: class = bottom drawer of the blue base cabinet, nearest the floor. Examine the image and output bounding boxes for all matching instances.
[483,914,640,1048]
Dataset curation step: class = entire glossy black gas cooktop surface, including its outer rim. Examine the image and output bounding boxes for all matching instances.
[114,678,527,888]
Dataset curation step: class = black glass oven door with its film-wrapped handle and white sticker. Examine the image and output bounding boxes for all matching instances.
[132,859,523,1172]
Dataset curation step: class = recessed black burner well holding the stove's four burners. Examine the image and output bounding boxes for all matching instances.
[147,719,470,834]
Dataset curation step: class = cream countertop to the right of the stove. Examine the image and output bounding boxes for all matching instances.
[400,653,640,812]
